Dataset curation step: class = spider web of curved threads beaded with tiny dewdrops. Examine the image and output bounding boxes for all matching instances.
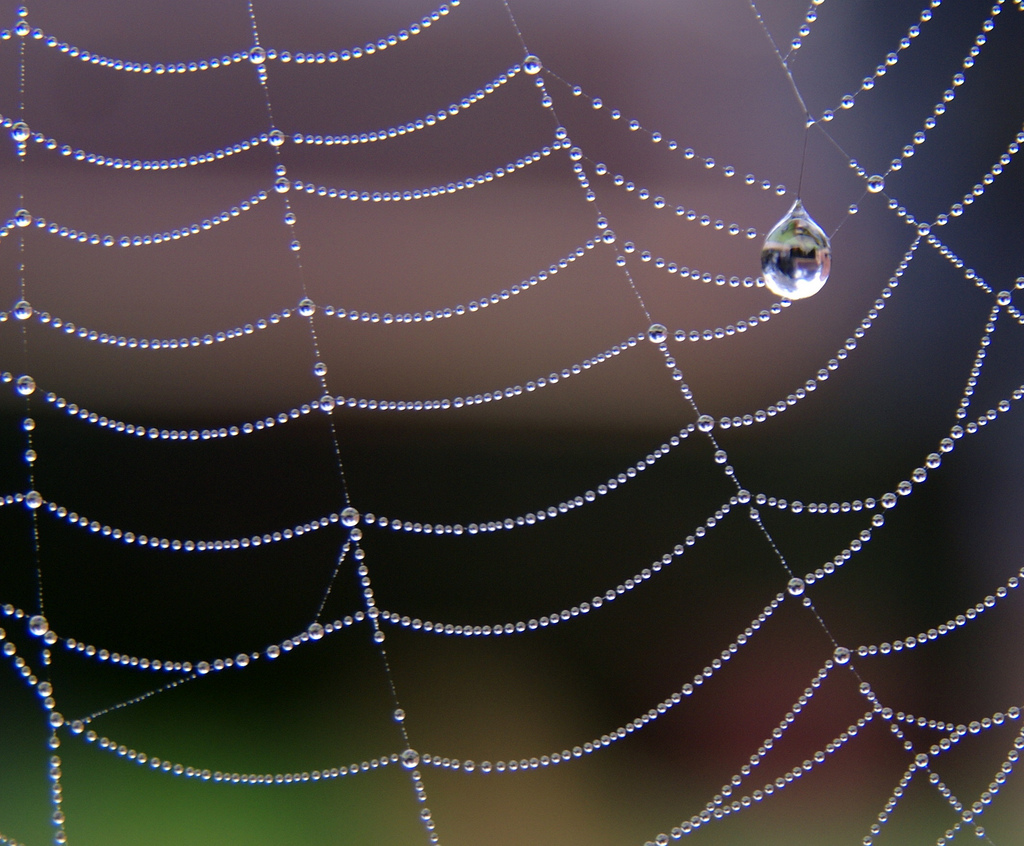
[0,0,1024,846]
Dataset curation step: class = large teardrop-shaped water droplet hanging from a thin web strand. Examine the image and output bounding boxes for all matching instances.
[761,200,831,300]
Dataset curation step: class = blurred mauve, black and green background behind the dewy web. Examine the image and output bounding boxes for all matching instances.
[0,0,1024,846]
